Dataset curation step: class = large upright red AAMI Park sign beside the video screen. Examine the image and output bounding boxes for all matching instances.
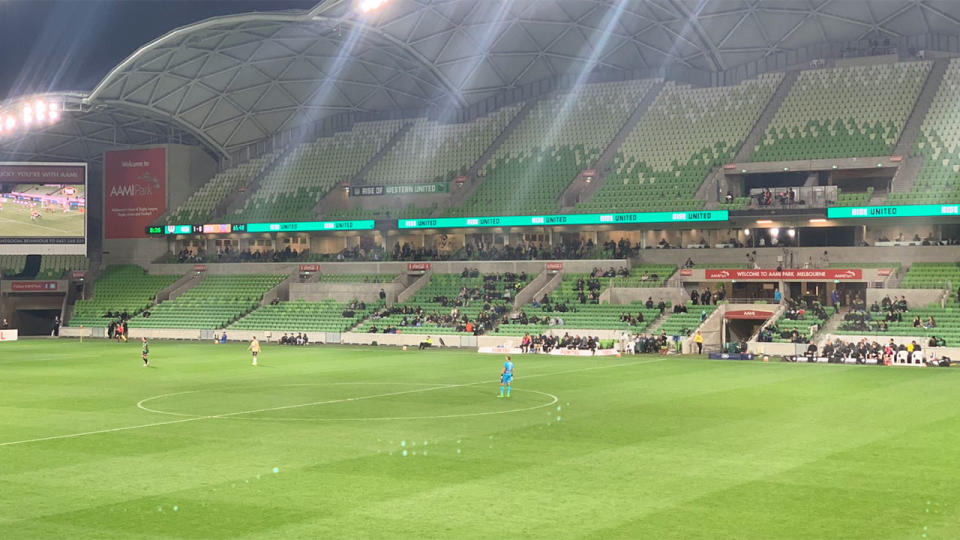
[103,148,167,239]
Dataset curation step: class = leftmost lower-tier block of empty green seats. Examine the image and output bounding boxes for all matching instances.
[68,265,180,327]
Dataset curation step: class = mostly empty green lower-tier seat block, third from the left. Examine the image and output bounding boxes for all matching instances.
[229,300,383,334]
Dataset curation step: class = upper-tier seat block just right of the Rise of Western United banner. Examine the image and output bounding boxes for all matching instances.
[447,80,655,216]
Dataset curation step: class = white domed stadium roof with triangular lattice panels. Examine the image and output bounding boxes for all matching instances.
[0,0,960,159]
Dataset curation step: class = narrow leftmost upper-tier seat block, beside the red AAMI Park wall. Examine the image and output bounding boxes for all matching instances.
[163,152,278,225]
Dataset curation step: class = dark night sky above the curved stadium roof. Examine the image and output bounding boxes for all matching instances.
[0,0,319,100]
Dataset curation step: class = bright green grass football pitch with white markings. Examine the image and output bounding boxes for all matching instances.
[0,340,960,539]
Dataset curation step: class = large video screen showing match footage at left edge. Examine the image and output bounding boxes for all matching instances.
[0,162,87,255]
